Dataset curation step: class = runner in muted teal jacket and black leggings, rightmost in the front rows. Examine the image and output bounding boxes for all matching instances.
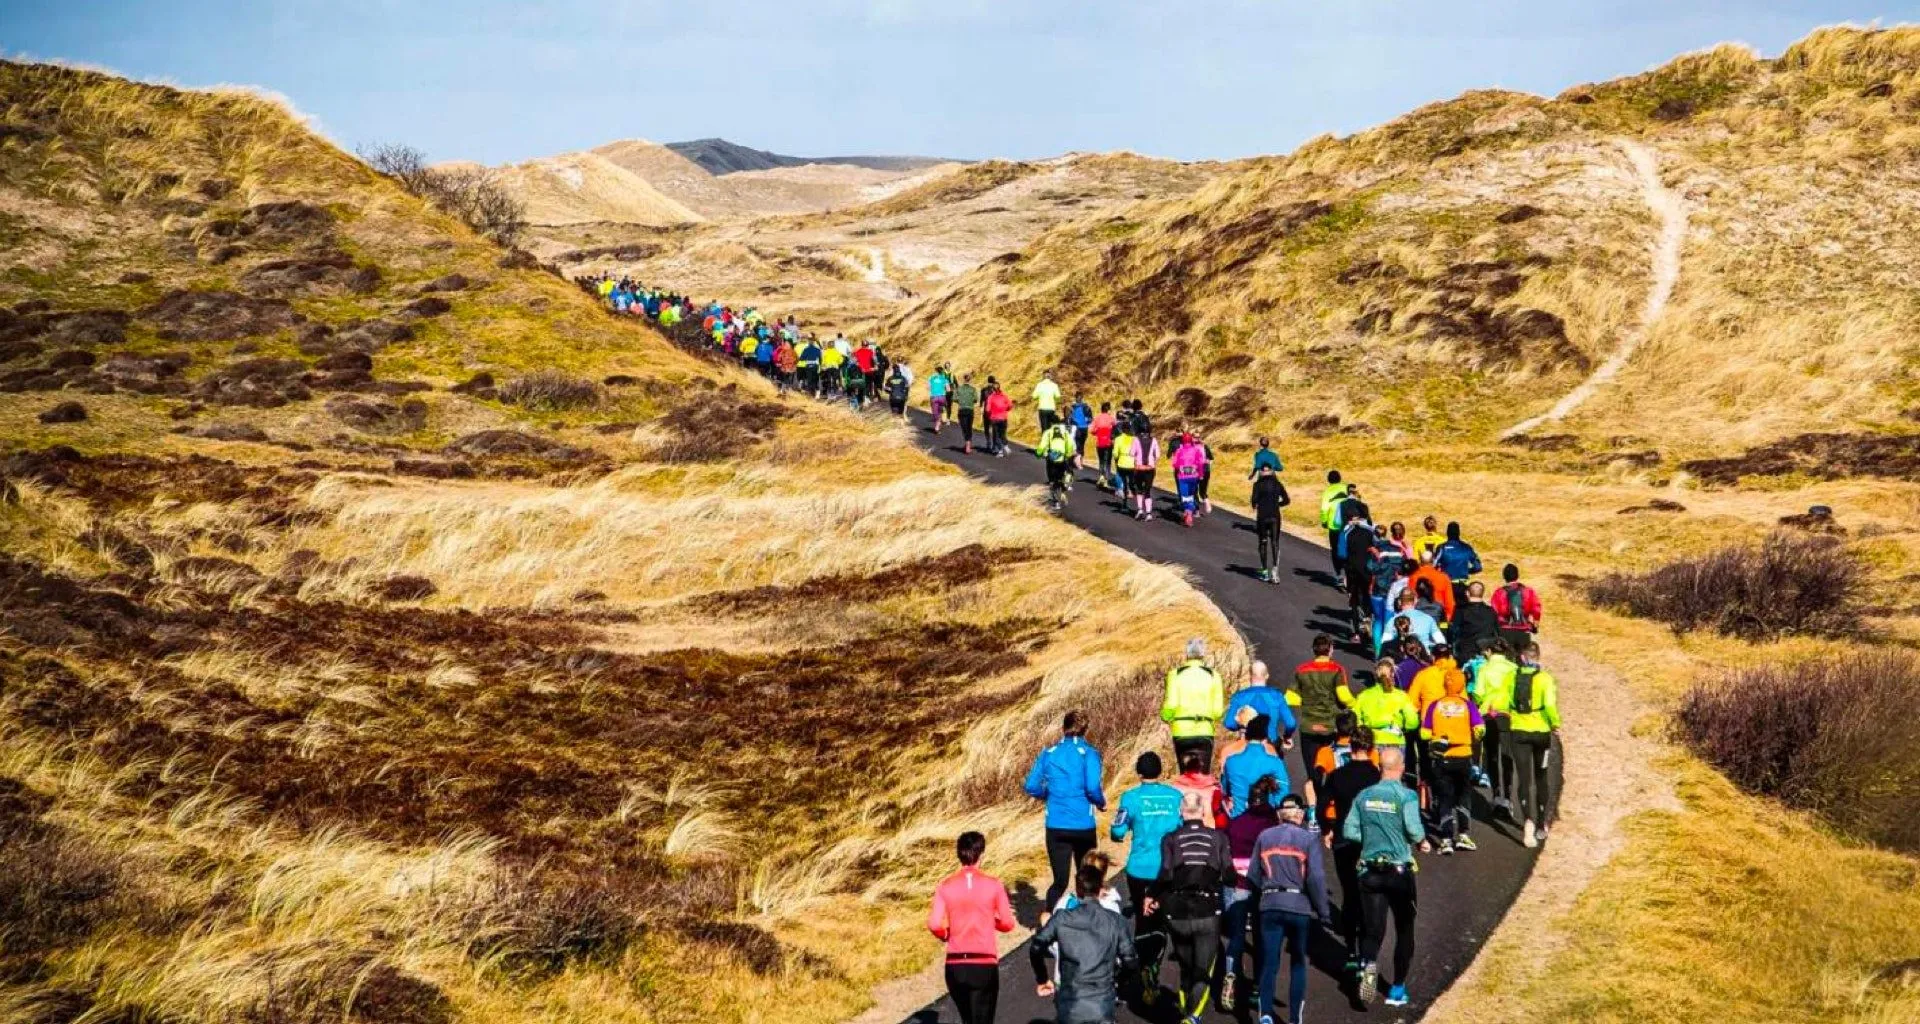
[1340,745,1427,1007]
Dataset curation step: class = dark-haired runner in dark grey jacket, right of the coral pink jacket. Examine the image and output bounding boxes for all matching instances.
[1031,863,1139,1024]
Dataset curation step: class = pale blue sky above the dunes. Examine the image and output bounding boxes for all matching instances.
[0,0,1920,163]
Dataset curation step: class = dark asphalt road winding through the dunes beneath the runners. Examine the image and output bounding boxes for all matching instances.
[906,411,1534,1024]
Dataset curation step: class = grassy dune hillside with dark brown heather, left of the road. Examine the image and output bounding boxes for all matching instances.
[0,63,1233,1024]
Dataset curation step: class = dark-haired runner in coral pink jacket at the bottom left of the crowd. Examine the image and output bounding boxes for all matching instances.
[927,832,1014,1024]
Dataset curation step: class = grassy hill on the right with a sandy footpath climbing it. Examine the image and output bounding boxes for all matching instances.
[887,29,1920,457]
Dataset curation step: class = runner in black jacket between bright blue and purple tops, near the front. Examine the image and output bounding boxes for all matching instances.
[1146,793,1238,1020]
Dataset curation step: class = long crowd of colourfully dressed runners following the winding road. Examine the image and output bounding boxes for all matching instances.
[580,268,1561,1024]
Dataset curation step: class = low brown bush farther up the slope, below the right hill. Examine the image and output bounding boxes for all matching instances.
[1586,532,1866,640]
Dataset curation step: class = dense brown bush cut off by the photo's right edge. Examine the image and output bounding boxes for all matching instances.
[1674,647,1920,853]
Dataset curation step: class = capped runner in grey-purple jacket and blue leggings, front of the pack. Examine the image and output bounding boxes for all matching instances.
[1246,793,1332,1024]
